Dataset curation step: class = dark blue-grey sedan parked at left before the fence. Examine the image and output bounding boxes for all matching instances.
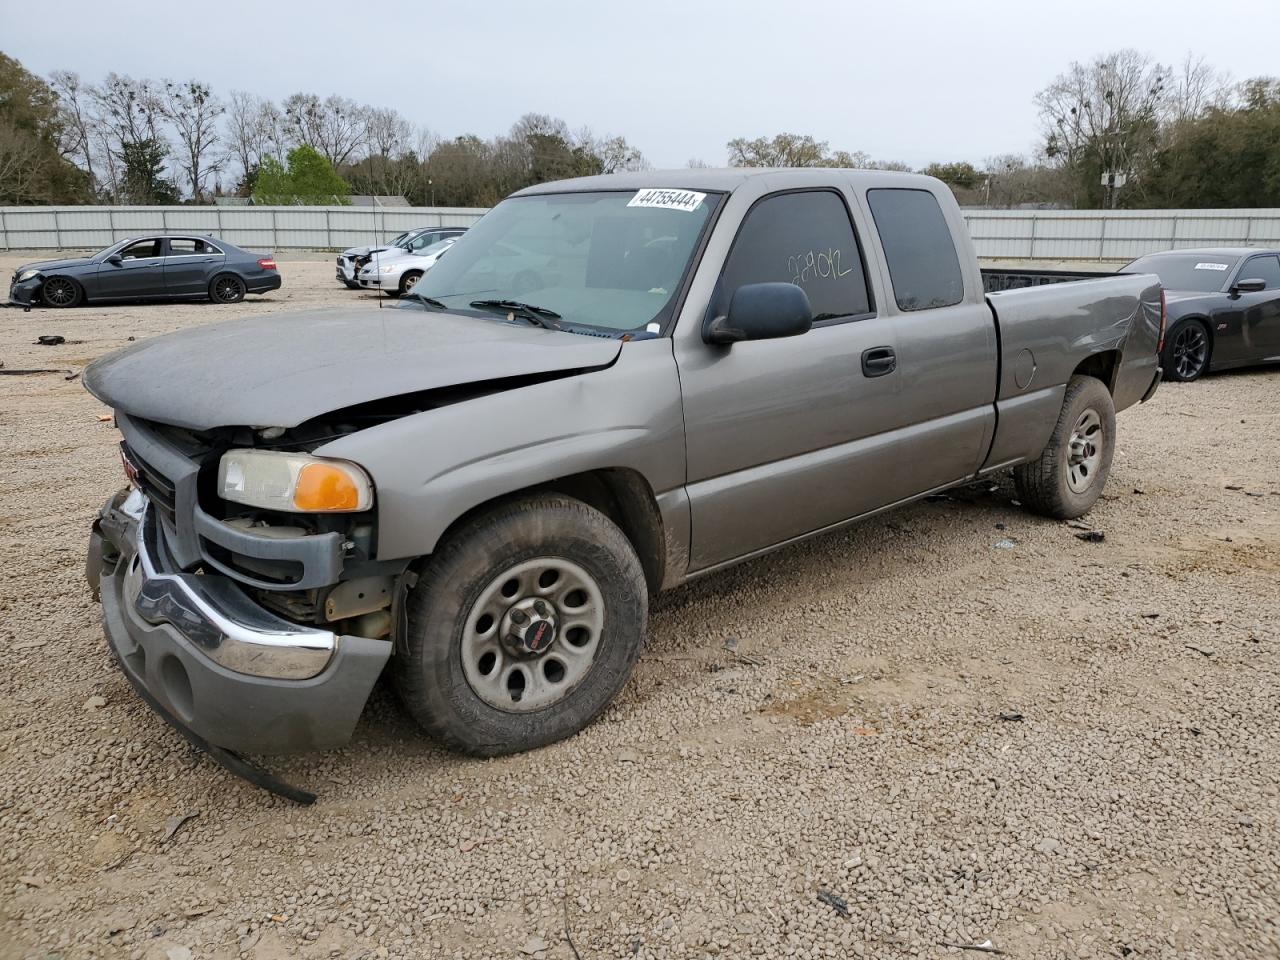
[9,234,280,307]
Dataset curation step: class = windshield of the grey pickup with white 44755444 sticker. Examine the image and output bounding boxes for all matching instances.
[413,191,719,333]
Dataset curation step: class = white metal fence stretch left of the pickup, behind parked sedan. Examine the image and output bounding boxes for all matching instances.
[0,206,485,252]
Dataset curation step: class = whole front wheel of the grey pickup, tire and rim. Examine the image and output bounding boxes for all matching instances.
[392,495,649,756]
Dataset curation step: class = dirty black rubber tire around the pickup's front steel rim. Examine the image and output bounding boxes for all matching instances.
[392,494,649,756]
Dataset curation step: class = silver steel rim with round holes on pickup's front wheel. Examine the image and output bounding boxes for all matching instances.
[461,557,604,713]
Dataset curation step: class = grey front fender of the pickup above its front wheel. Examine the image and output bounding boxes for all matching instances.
[315,339,685,559]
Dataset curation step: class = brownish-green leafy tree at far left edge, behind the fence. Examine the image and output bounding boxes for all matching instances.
[0,54,90,204]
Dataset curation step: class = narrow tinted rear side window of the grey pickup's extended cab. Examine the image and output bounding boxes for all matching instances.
[867,189,964,316]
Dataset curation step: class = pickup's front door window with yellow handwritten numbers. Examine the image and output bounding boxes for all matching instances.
[722,191,870,320]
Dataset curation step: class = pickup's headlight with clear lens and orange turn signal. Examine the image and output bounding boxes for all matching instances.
[218,451,374,513]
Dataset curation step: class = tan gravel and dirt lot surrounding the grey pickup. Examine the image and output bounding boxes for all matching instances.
[0,257,1280,960]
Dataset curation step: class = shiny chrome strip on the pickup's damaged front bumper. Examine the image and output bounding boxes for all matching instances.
[120,490,338,680]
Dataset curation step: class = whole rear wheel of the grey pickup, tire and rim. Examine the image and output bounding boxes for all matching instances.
[1014,376,1116,520]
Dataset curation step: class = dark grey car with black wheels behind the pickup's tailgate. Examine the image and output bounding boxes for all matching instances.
[1120,247,1280,380]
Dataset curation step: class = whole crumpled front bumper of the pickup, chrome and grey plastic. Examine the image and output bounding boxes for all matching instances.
[86,490,392,754]
